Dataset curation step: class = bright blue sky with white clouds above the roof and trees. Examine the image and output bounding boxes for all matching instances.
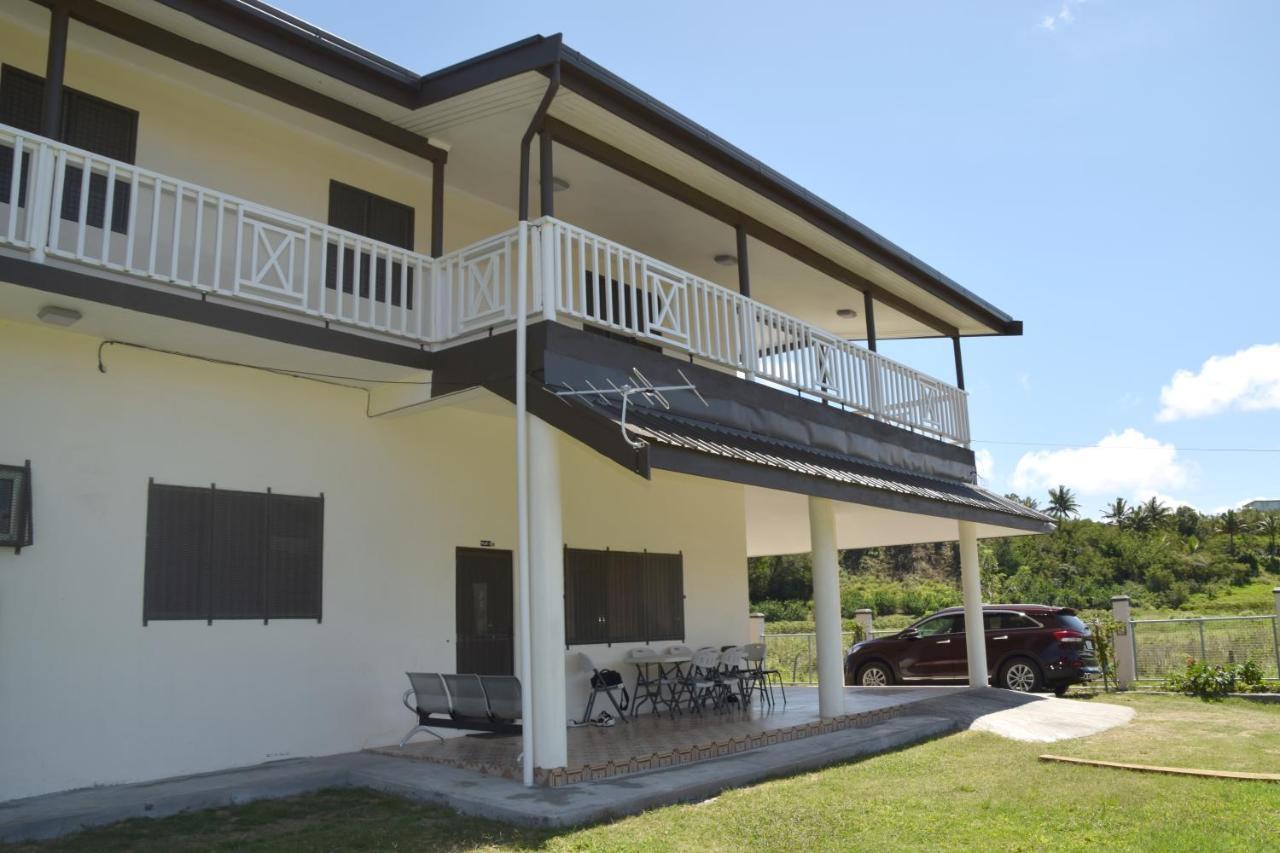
[290,0,1280,515]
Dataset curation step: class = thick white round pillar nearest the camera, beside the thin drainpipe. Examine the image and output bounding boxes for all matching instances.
[524,415,568,770]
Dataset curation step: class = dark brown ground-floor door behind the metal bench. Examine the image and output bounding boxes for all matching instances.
[456,548,516,675]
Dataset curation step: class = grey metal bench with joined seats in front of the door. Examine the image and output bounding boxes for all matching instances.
[401,672,521,747]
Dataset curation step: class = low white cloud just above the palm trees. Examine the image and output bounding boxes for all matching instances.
[1010,428,1188,500]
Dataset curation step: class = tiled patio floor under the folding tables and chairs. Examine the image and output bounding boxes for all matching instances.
[374,686,956,785]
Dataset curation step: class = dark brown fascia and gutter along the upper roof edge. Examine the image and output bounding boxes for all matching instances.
[120,0,1021,334]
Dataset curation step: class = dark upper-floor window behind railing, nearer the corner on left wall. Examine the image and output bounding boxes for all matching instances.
[325,181,413,310]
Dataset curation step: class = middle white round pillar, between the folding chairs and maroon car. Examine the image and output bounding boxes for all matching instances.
[809,497,845,717]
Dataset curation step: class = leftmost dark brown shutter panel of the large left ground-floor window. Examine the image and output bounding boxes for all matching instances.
[142,483,211,622]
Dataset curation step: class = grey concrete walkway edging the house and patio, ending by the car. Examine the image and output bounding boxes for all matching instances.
[0,688,1129,841]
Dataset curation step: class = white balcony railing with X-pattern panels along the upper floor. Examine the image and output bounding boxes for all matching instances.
[0,126,969,444]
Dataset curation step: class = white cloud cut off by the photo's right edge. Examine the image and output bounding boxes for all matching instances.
[1156,343,1280,421]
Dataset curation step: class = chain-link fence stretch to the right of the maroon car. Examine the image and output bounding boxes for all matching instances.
[1131,616,1280,681]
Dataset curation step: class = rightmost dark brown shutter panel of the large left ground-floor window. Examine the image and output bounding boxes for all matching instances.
[264,494,324,620]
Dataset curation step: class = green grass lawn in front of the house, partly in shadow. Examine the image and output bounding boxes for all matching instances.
[15,695,1280,852]
